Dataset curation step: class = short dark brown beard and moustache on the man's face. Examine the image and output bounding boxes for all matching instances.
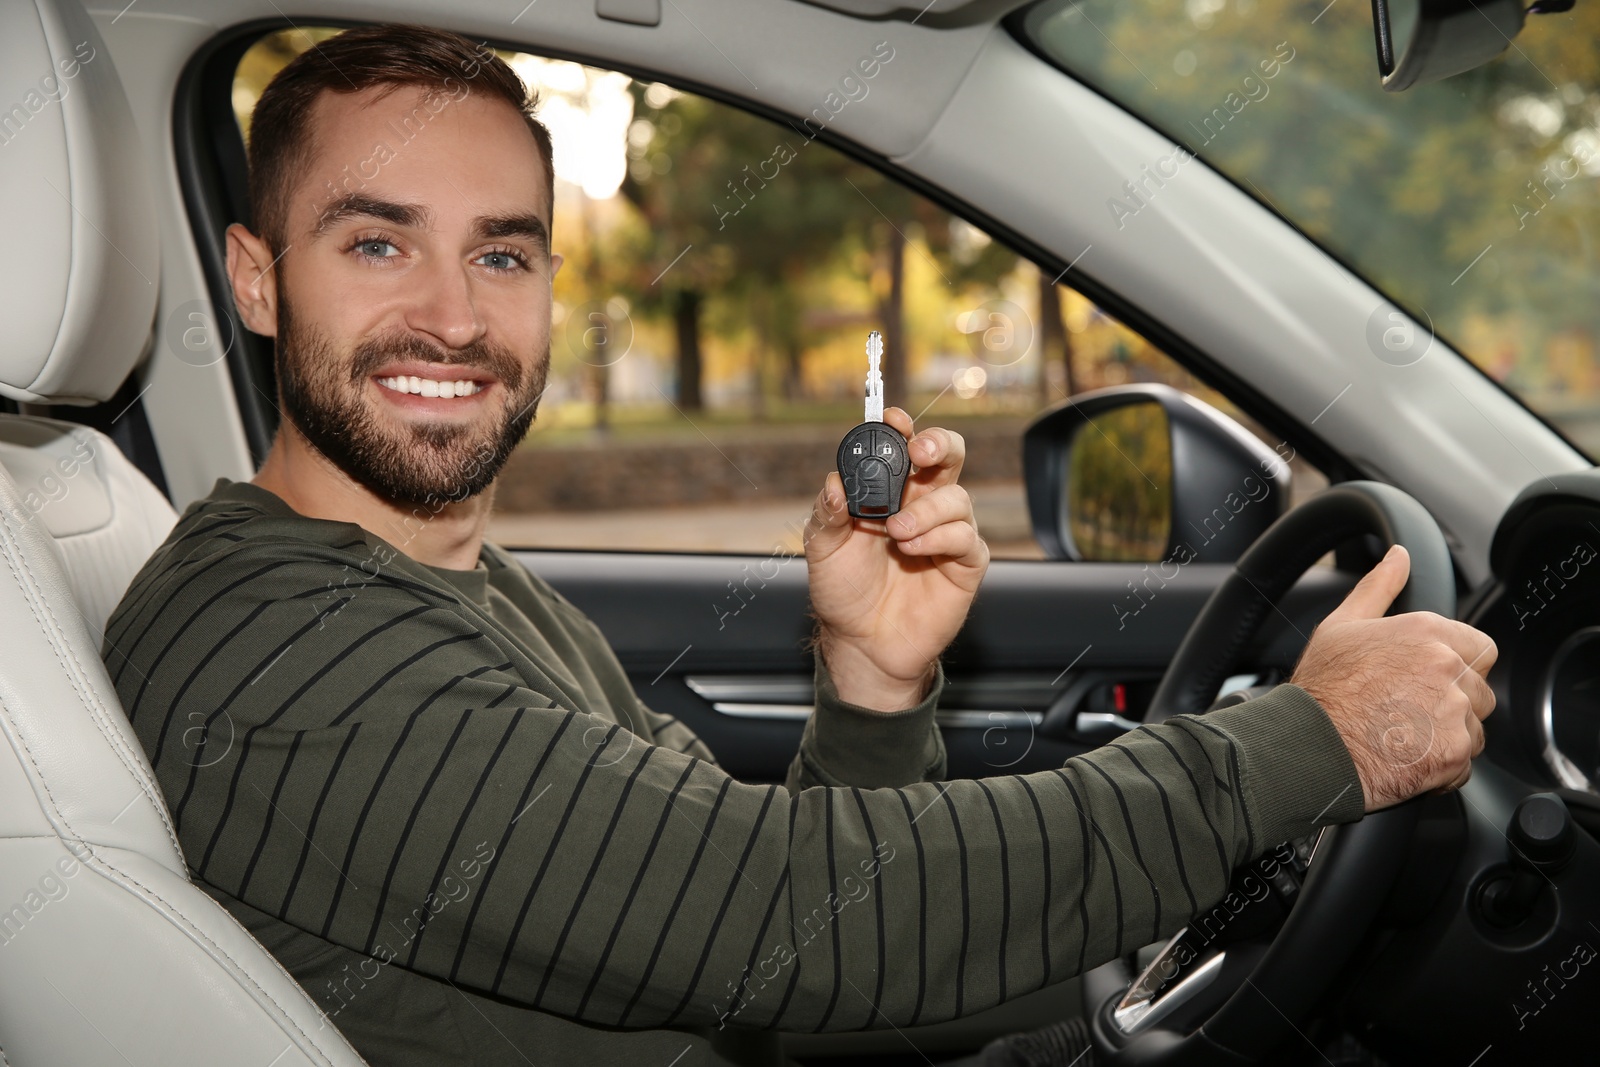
[274,290,550,510]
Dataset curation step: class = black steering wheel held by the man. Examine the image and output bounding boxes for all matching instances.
[1083,482,1456,1067]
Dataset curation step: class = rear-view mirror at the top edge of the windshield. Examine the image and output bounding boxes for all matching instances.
[1373,0,1529,93]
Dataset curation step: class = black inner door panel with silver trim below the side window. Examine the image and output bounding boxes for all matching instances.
[514,550,1354,782]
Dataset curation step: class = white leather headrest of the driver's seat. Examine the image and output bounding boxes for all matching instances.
[0,0,160,405]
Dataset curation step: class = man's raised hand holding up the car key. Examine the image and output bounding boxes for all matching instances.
[805,408,989,710]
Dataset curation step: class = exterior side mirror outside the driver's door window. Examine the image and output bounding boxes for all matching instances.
[1022,384,1290,563]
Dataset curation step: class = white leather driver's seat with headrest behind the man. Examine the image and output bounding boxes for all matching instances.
[0,0,362,1067]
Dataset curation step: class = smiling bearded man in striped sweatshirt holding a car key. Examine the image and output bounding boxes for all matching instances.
[104,27,1494,1067]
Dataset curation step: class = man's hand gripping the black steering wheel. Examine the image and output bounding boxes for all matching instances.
[1290,545,1499,811]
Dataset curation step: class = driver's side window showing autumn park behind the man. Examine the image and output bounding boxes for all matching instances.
[234,27,1325,558]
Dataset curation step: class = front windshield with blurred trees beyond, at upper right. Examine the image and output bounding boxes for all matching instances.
[1021,0,1600,459]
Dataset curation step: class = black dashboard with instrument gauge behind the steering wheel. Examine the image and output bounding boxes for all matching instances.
[1296,469,1600,1067]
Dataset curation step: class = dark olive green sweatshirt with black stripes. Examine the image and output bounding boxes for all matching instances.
[102,478,1363,1067]
